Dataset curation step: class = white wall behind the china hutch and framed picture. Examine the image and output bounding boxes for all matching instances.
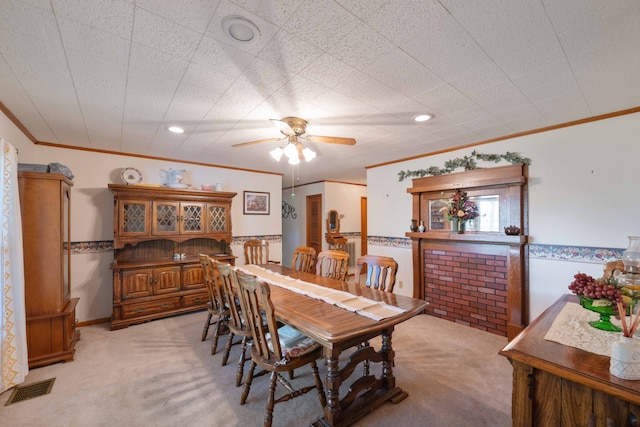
[0,108,282,322]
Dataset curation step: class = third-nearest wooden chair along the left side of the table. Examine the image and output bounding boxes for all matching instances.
[198,254,229,355]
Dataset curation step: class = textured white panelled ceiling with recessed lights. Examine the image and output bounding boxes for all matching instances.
[0,0,640,186]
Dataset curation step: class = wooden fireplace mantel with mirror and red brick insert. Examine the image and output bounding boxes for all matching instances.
[406,165,528,340]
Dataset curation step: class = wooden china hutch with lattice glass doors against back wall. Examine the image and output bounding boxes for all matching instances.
[109,184,236,330]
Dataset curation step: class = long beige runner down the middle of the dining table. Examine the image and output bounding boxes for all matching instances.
[236,265,406,321]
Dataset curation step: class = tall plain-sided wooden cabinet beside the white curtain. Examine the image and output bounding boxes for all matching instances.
[18,172,80,368]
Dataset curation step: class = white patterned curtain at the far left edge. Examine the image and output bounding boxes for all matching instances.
[0,138,29,393]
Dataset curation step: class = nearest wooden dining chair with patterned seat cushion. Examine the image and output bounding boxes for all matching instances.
[236,271,327,427]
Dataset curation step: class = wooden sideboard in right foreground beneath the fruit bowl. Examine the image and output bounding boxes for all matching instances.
[500,295,640,427]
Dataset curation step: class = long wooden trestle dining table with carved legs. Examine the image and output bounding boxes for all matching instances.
[240,264,428,426]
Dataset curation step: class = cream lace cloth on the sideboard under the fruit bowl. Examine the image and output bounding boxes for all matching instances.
[544,302,637,356]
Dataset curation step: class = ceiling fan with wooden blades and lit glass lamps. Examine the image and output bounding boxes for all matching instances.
[233,117,356,165]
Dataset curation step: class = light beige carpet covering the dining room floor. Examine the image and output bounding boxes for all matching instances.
[0,312,512,427]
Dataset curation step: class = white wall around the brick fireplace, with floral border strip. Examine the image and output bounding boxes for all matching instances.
[367,114,640,319]
